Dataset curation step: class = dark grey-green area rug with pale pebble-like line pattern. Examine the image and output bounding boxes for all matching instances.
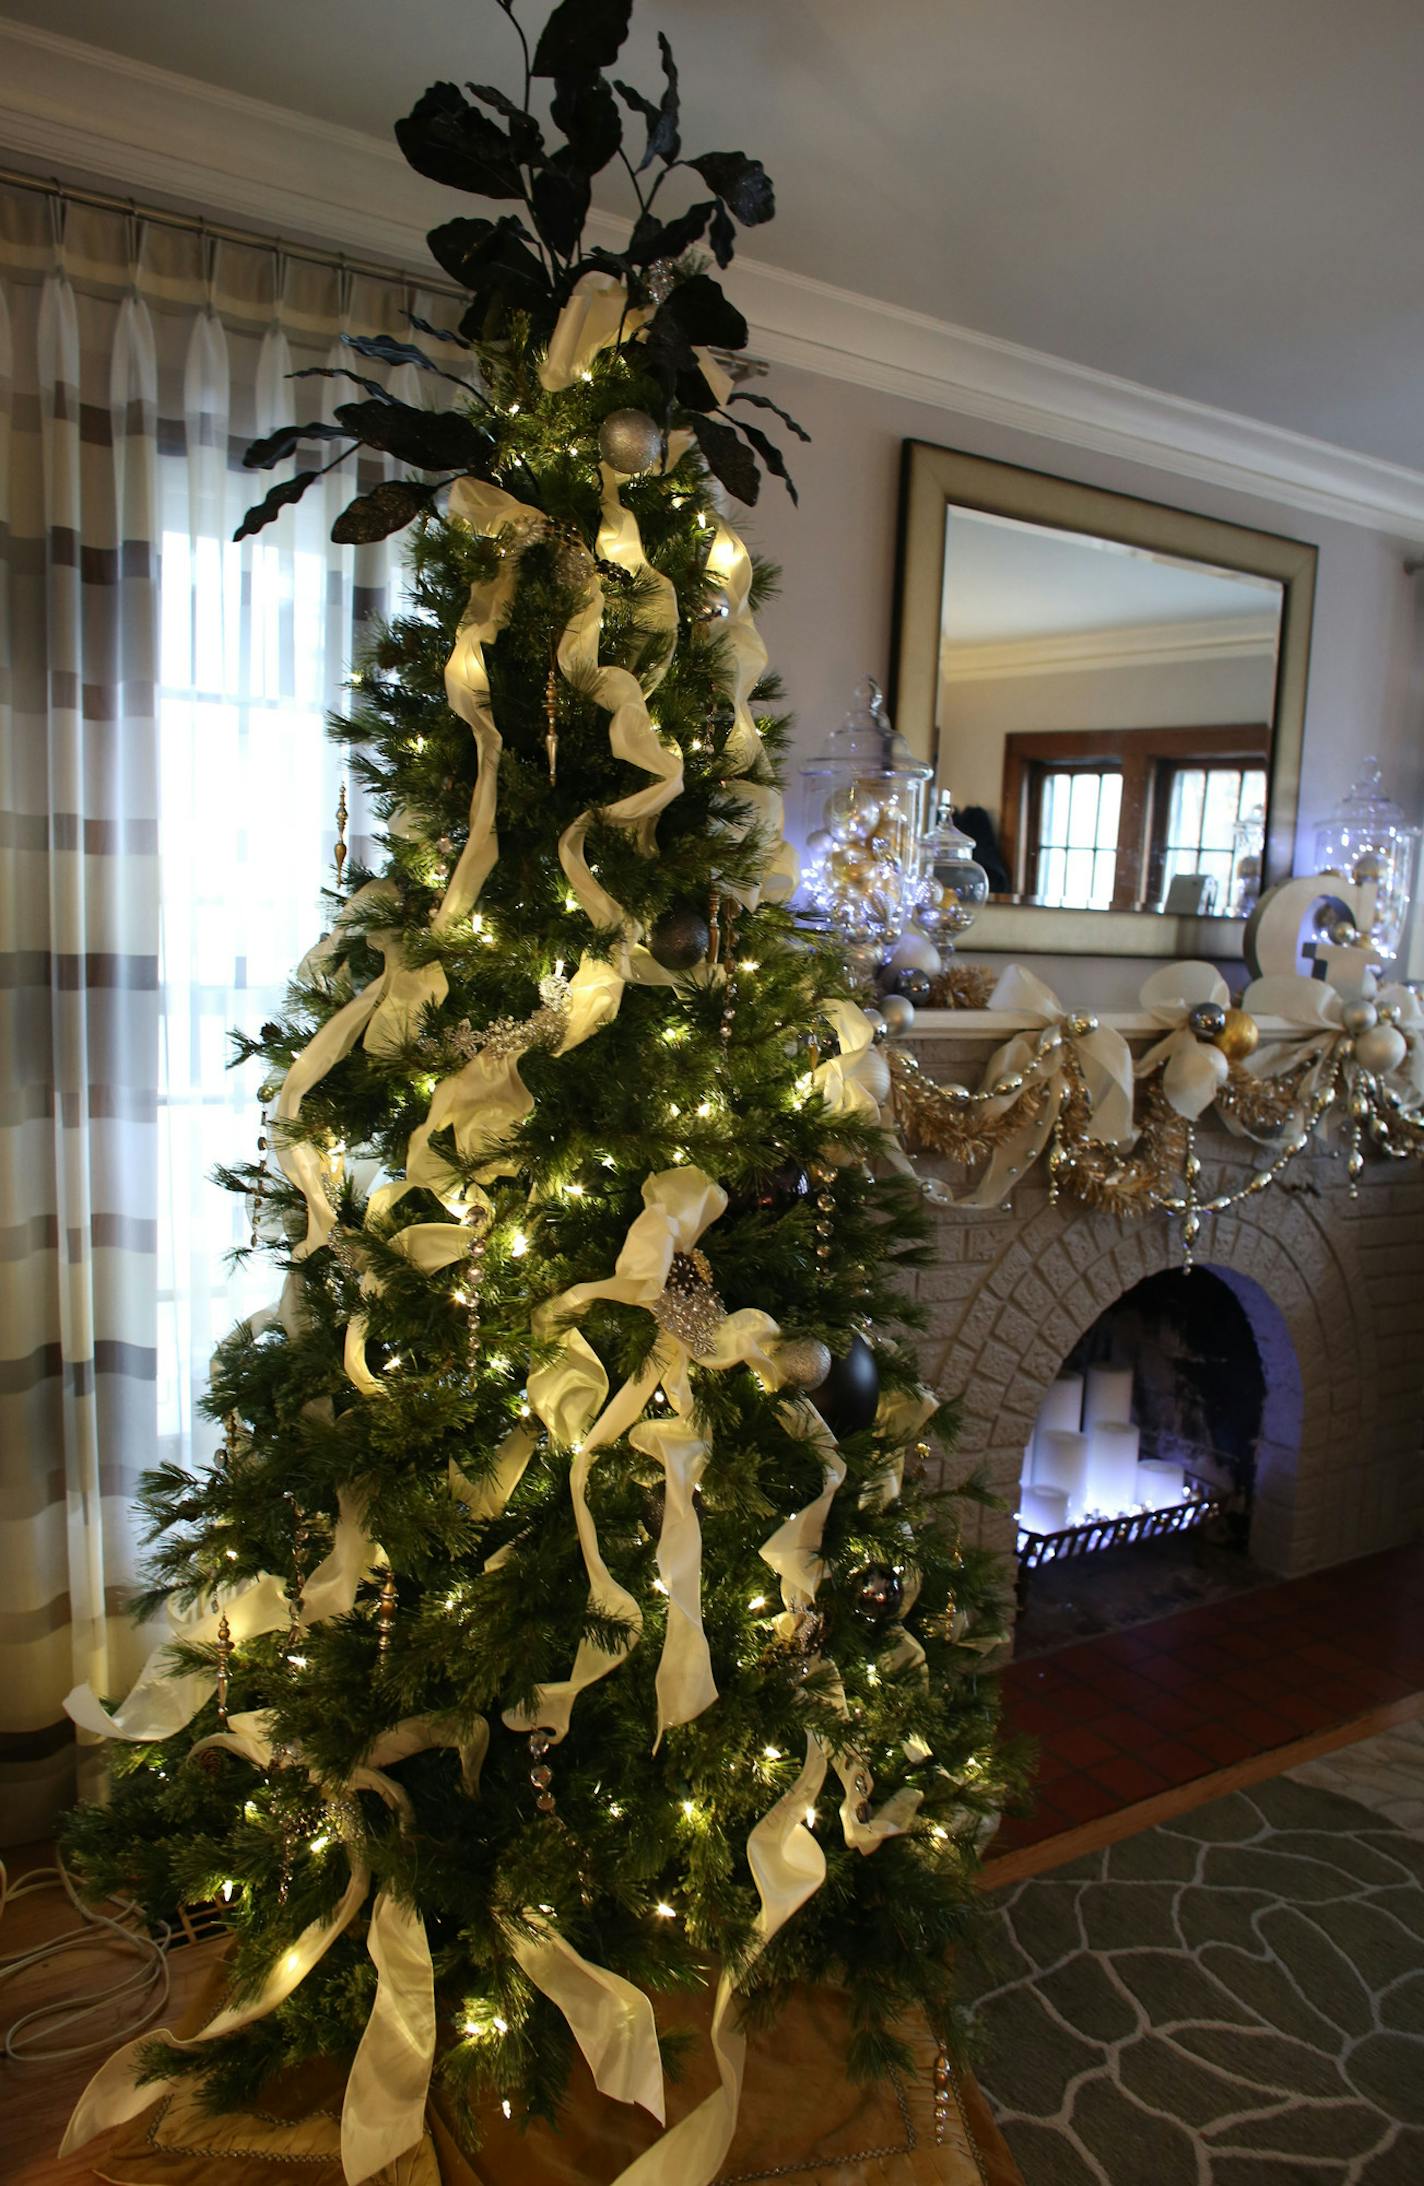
[965,1747,1424,2186]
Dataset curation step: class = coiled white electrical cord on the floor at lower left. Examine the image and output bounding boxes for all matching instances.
[0,1860,173,2064]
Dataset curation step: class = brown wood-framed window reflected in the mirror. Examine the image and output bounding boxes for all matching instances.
[1002,724,1269,914]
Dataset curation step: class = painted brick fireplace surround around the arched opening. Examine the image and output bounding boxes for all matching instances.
[906,1010,1424,1608]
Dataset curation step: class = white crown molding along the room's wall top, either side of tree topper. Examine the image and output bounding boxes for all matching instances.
[0,22,1424,542]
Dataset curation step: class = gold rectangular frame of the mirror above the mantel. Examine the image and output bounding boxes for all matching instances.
[890,439,1319,957]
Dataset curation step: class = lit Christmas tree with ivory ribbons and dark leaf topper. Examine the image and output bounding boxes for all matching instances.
[68,0,1004,2186]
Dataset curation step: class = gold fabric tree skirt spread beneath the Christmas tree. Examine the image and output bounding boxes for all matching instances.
[94,1991,1019,2186]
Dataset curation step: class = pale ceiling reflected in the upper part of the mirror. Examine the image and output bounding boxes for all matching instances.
[943,509,1282,651]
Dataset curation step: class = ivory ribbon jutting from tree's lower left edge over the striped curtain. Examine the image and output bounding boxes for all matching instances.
[63,1489,372,1744]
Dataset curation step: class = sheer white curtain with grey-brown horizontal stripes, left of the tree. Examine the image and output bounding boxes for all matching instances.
[0,188,448,1843]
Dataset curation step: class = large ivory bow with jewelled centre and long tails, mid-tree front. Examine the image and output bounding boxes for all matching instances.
[503,1165,781,1740]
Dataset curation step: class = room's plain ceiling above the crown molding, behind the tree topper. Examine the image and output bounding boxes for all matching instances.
[0,0,1424,470]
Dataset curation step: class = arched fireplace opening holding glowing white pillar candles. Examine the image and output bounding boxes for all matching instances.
[1017,1266,1302,1653]
